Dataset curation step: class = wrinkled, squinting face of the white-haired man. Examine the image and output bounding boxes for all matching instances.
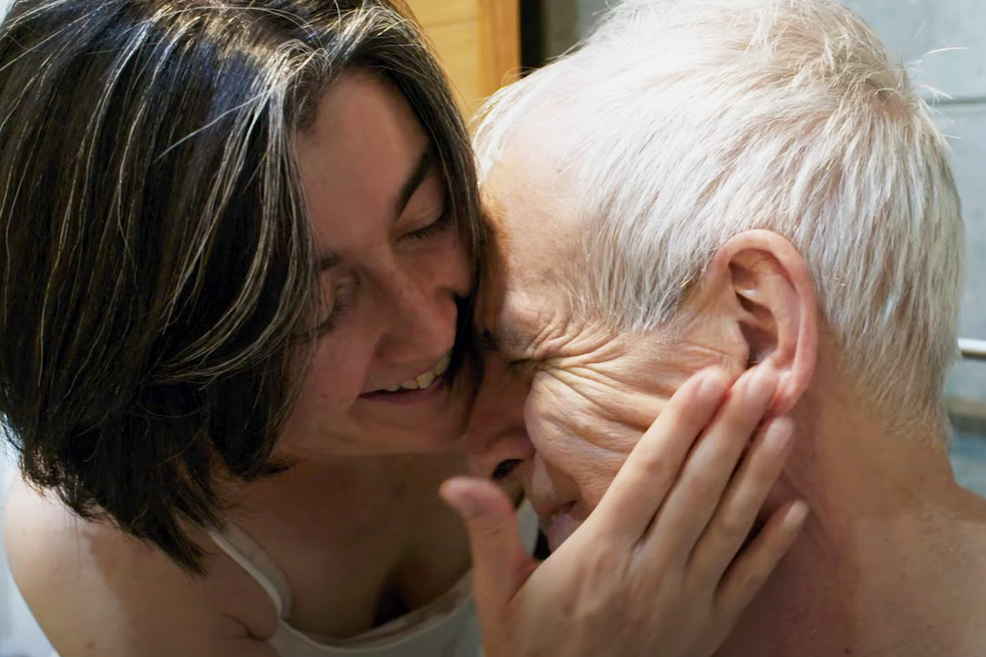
[469,130,749,549]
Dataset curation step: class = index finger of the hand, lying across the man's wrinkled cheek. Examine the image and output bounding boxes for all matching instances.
[573,369,729,543]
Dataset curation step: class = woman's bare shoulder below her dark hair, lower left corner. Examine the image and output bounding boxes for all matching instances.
[3,478,274,657]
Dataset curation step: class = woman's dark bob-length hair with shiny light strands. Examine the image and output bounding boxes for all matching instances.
[0,0,482,573]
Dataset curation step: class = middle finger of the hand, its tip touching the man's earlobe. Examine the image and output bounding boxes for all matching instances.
[648,367,777,566]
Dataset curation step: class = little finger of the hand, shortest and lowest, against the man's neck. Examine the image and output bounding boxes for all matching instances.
[715,500,808,627]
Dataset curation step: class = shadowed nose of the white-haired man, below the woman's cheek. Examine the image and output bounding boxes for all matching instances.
[466,351,534,477]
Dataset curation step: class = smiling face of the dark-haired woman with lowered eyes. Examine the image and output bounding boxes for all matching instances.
[280,68,475,456]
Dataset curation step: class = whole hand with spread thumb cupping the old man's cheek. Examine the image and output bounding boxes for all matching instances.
[442,367,807,657]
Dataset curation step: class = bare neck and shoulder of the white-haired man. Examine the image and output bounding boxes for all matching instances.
[718,354,986,657]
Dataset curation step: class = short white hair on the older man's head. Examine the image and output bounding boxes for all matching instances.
[475,0,964,418]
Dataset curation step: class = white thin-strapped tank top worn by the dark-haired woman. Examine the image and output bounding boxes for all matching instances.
[209,502,537,657]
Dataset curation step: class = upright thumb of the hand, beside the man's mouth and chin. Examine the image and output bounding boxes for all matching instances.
[439,477,537,616]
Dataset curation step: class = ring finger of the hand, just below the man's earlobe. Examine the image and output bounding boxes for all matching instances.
[689,418,794,587]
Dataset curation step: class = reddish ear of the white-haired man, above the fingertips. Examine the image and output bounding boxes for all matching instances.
[709,230,818,415]
